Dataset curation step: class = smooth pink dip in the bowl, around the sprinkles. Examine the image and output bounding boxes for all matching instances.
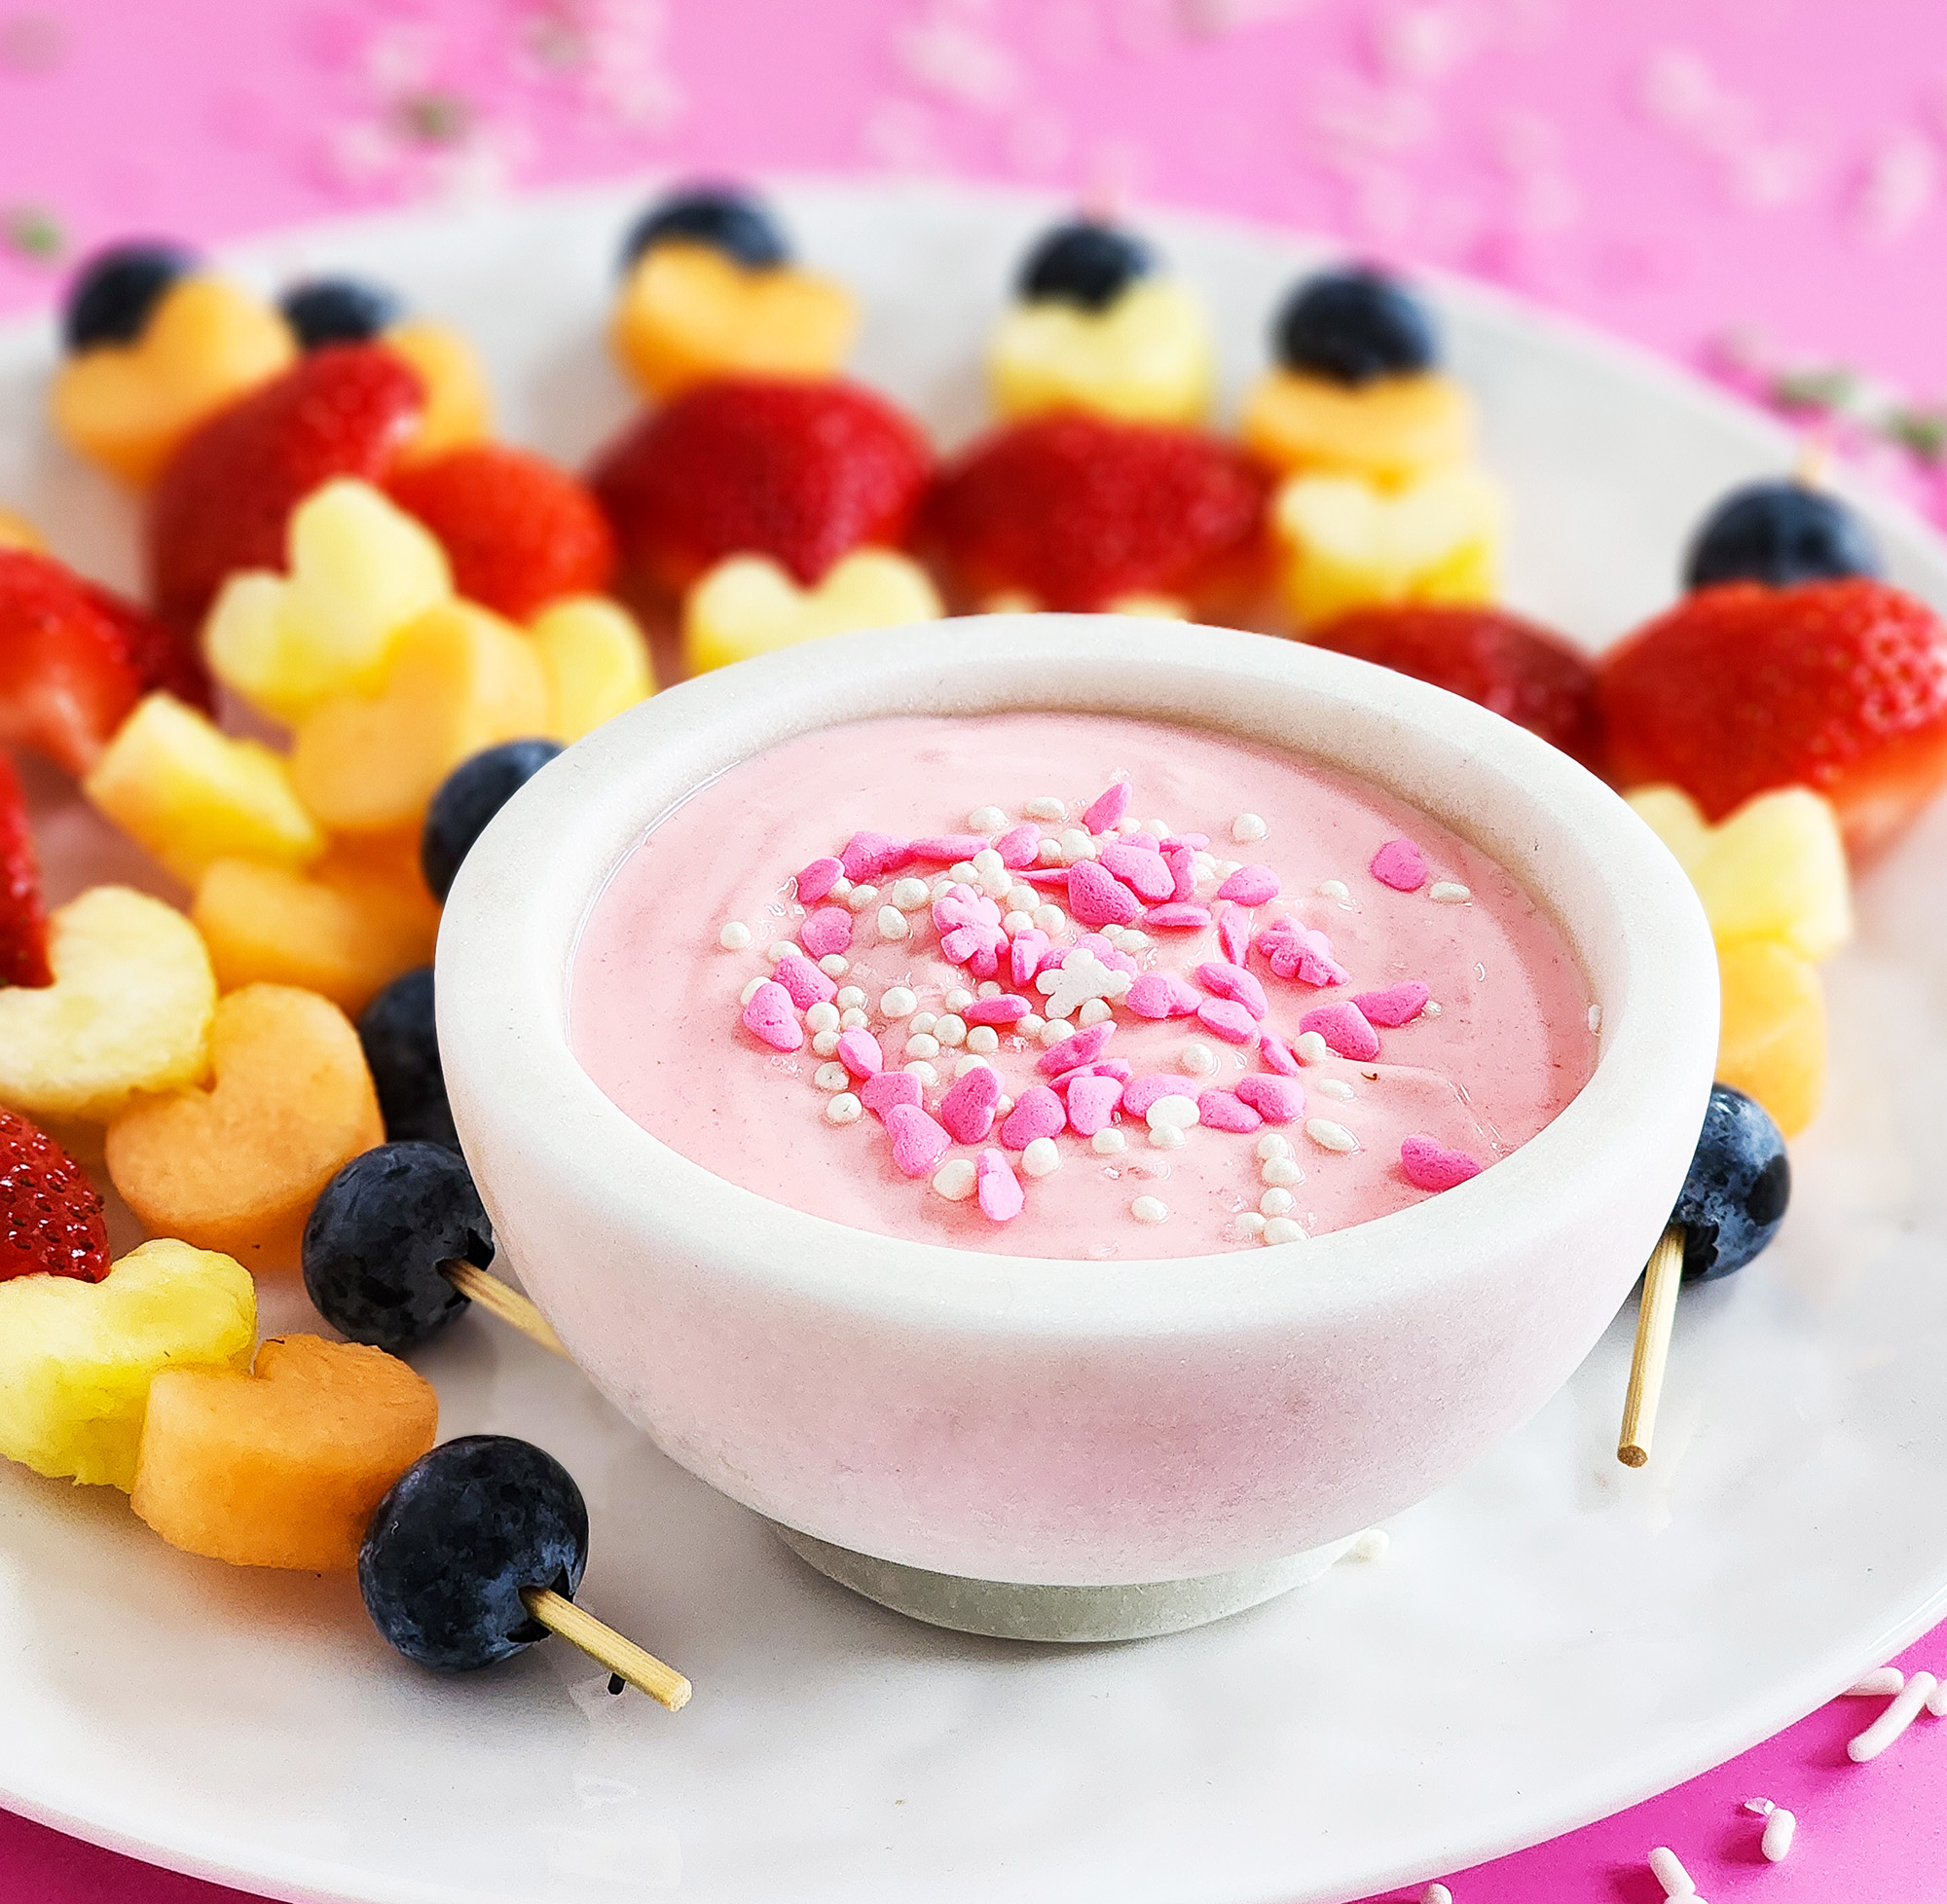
[570,713,1597,1260]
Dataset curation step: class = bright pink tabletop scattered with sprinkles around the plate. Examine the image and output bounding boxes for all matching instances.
[0,0,1947,1904]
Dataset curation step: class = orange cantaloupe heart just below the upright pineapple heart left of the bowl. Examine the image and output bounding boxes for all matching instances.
[290,600,549,833]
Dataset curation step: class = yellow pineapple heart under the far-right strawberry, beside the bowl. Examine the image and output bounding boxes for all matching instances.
[1630,787,1852,964]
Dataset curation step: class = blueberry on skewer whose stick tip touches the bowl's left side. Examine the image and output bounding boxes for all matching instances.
[304,1143,493,1355]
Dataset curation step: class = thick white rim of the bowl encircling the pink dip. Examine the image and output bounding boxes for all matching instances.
[436,613,1717,1339]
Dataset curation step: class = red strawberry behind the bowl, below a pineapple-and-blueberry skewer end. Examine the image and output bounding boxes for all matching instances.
[927,411,1267,611]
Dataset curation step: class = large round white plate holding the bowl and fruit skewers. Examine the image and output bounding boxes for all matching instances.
[0,174,1947,1904]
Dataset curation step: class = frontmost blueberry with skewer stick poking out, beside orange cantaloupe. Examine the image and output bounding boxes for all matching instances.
[358,1435,588,1672]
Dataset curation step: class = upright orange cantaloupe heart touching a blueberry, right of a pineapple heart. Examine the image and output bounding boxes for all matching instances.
[107,985,386,1275]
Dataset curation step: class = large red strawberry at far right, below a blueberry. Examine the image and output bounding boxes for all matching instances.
[1600,576,1947,857]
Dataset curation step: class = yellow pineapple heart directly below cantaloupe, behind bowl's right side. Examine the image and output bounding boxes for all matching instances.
[1271,465,1505,627]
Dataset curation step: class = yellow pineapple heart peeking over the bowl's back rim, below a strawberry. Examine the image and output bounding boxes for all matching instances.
[683,549,940,674]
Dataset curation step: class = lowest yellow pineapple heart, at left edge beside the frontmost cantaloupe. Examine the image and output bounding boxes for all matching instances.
[0,1240,257,1489]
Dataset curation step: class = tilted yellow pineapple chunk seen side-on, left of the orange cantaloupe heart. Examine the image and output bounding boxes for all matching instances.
[82,693,325,886]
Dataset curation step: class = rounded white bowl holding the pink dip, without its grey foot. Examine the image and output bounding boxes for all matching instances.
[438,615,1717,1596]
